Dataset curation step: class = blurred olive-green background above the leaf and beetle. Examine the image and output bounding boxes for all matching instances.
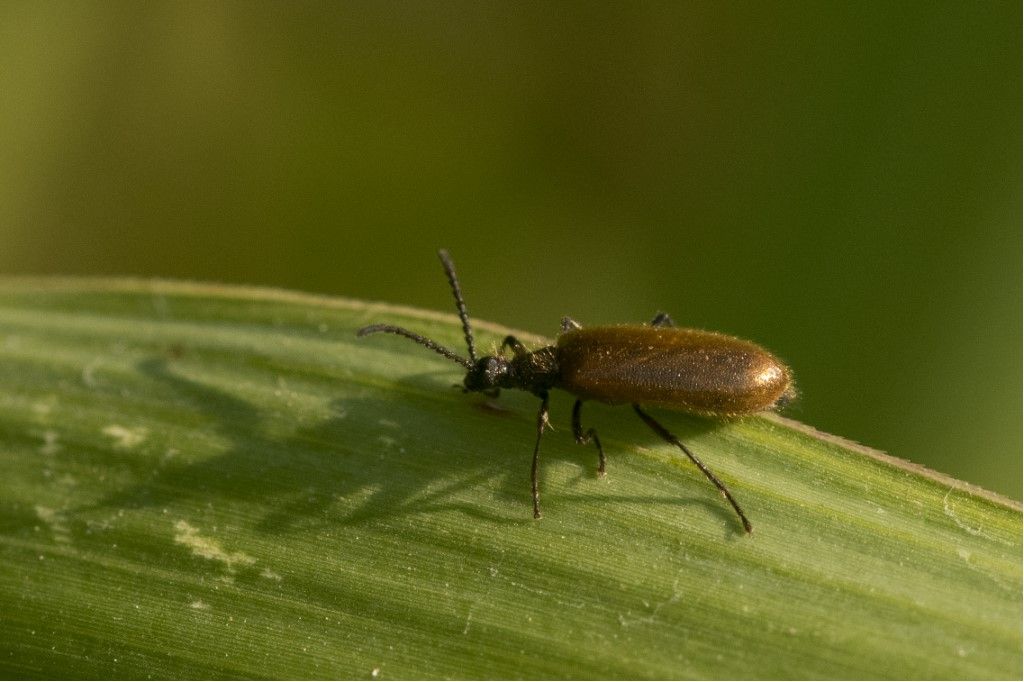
[0,1,1022,500]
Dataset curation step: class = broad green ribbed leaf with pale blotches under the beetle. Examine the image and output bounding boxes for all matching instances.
[0,280,1022,679]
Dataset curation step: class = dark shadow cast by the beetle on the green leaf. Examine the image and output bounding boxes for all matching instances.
[82,357,732,534]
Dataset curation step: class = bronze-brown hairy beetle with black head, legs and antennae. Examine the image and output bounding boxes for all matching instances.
[356,249,796,532]
